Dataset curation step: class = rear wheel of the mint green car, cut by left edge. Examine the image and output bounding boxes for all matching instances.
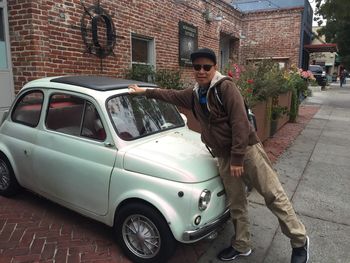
[0,154,20,196]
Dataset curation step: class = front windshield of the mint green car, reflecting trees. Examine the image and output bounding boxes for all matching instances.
[107,94,185,140]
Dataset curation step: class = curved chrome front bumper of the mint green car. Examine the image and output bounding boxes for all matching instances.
[183,209,230,242]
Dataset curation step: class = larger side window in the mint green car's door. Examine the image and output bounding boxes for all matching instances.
[45,94,106,141]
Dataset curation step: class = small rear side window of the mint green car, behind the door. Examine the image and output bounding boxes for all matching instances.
[11,91,44,127]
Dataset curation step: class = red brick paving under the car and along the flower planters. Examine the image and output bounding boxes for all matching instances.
[0,106,319,263]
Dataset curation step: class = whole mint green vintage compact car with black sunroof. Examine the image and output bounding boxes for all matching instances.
[0,76,229,262]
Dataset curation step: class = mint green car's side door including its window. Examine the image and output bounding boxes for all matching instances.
[33,93,116,215]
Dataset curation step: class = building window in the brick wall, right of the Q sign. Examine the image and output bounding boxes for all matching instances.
[131,35,155,66]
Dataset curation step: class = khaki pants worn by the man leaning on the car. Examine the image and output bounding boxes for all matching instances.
[219,143,306,253]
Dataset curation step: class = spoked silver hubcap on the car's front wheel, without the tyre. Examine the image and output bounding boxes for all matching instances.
[122,215,161,258]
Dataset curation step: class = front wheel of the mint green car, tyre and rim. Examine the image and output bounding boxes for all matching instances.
[114,203,176,263]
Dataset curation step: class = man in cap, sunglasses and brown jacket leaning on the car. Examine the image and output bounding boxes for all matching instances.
[129,48,309,263]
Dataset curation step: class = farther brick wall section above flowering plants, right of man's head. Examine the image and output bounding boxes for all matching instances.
[241,8,303,66]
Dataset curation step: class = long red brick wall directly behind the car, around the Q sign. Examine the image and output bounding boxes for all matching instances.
[8,0,241,91]
